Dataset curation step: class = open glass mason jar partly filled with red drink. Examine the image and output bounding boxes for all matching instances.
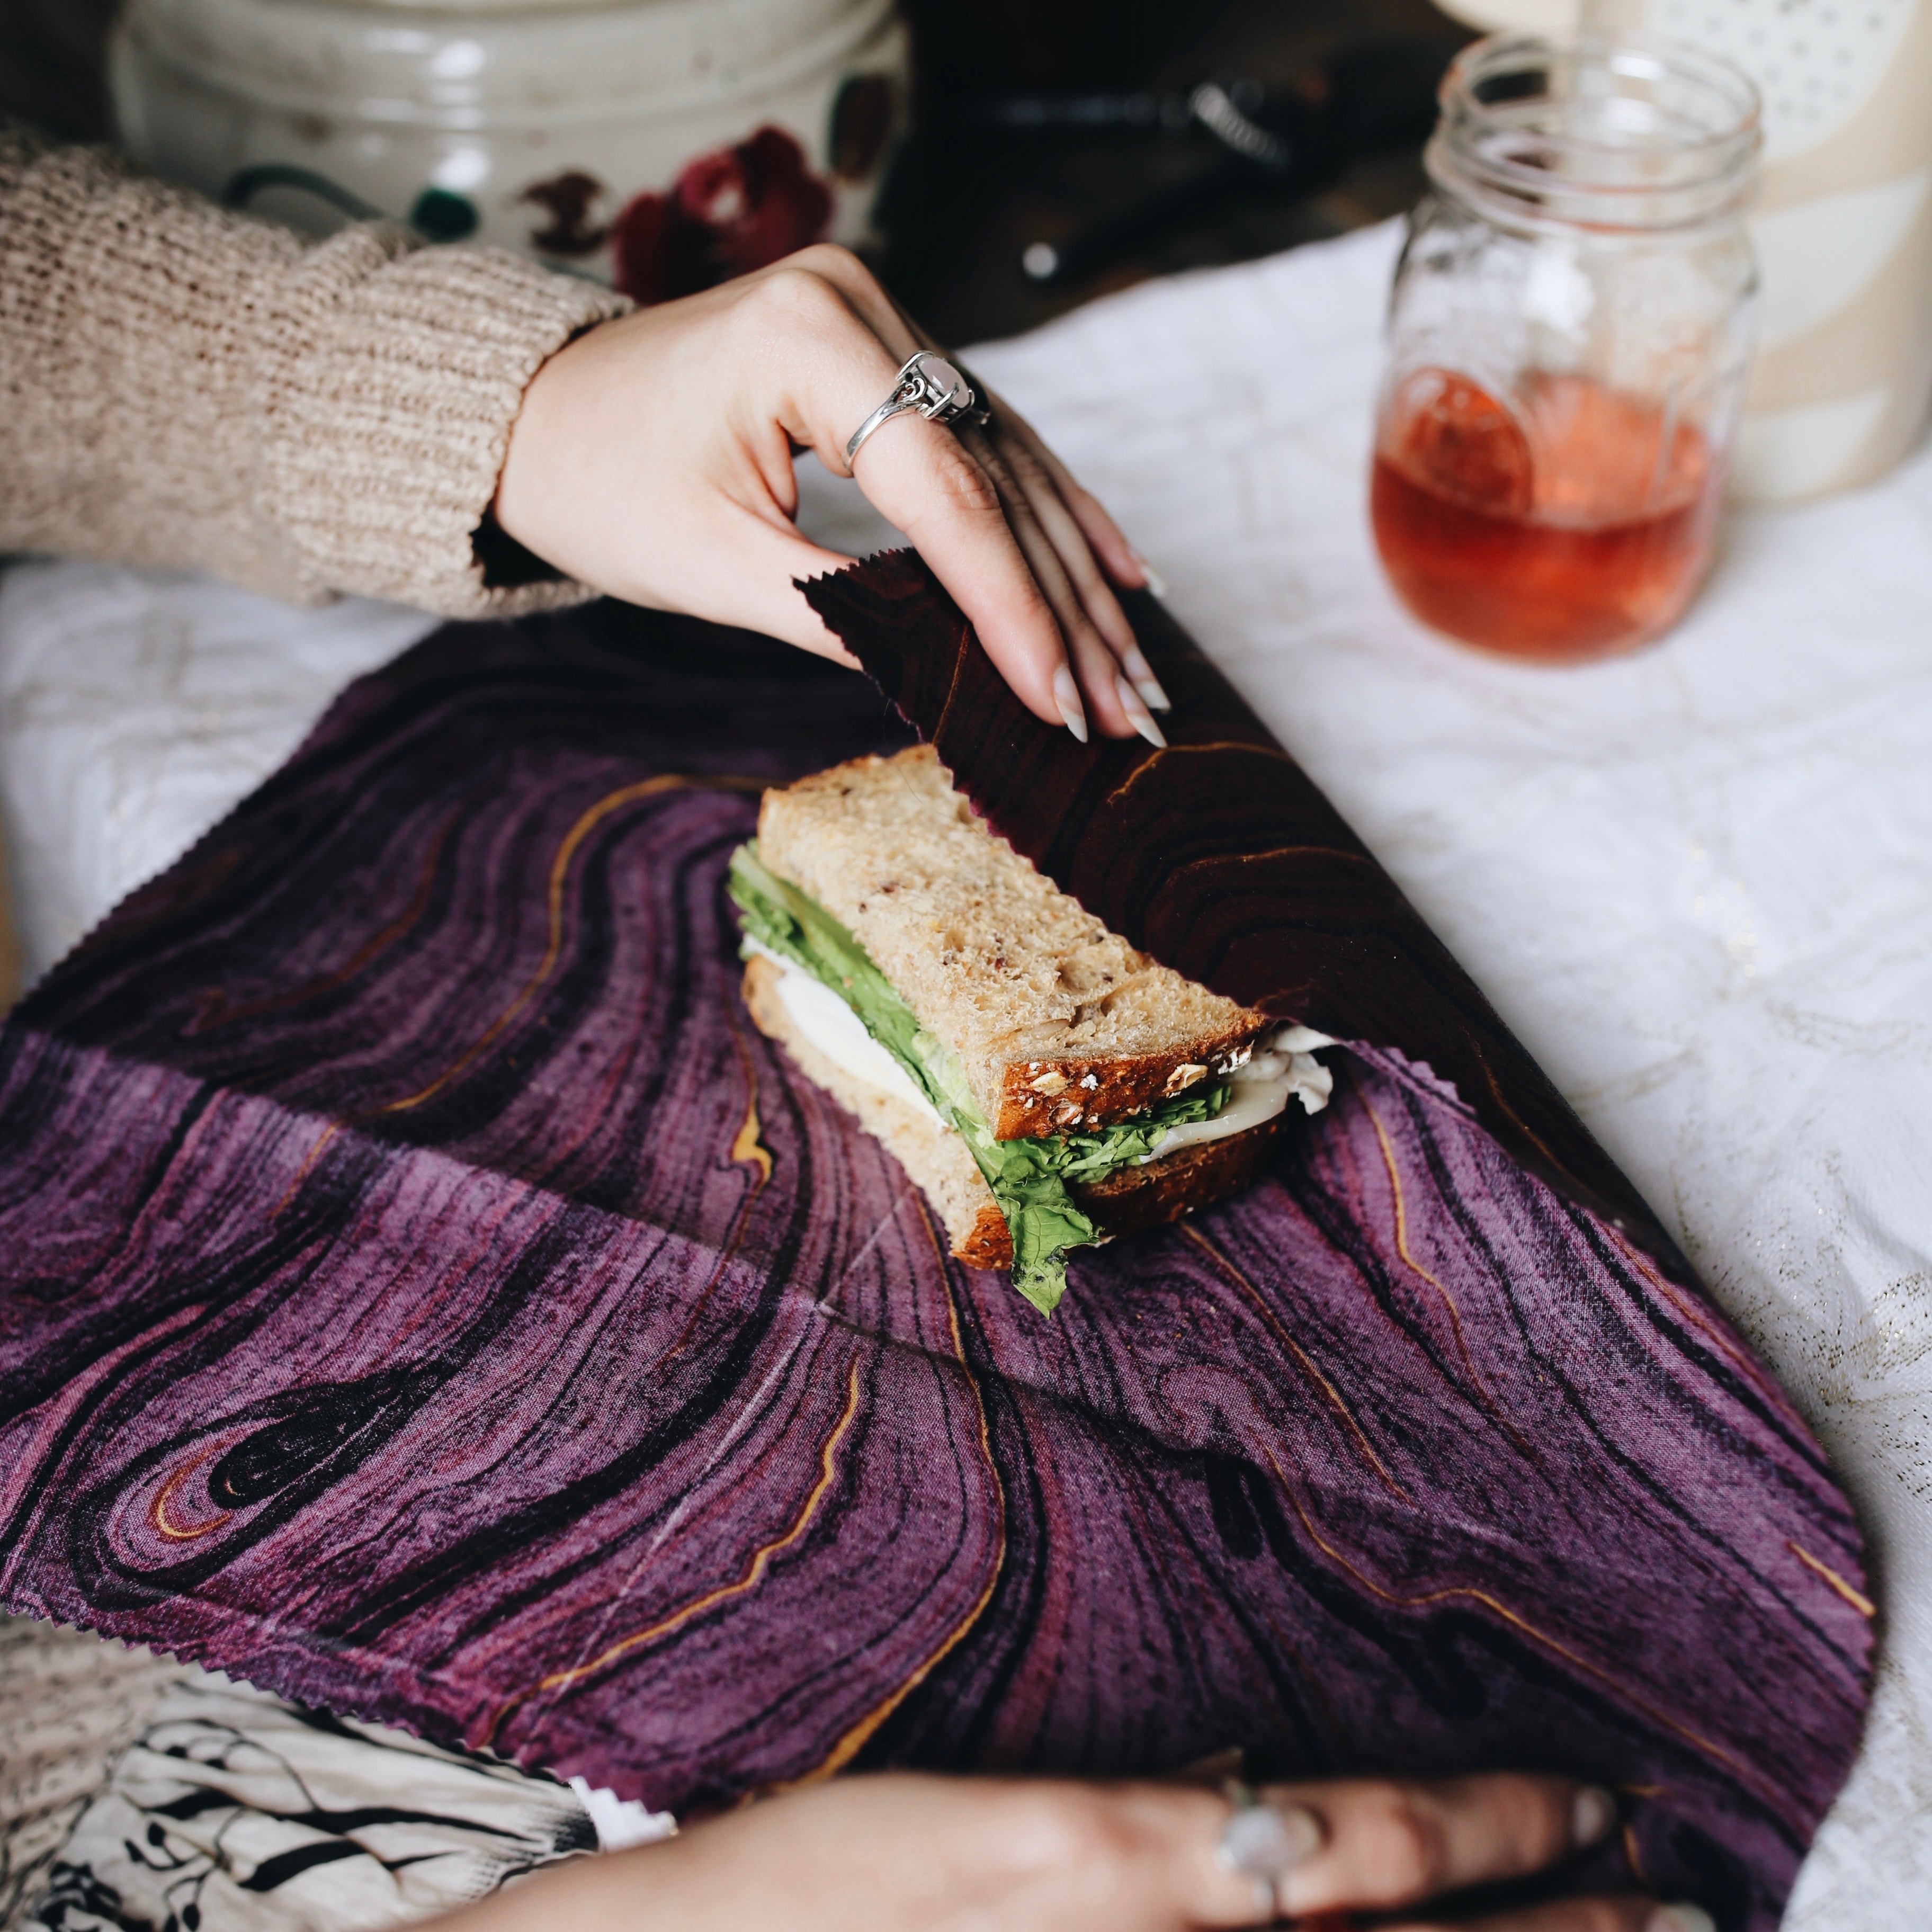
[1370,37,1760,663]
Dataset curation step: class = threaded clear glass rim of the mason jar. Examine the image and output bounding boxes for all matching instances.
[1424,33,1764,230]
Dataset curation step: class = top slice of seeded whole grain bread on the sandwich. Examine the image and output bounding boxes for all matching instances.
[757,746,1271,1140]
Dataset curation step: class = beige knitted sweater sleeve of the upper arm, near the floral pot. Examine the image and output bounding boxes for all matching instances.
[0,126,626,616]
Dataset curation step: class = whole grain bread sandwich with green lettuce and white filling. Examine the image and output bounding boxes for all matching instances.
[730,746,1335,1314]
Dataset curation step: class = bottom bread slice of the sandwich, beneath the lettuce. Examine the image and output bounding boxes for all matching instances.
[744,958,1287,1269]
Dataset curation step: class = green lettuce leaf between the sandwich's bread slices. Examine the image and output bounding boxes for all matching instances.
[728,840,1229,1314]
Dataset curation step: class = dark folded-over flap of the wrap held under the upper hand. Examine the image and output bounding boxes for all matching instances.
[798,551,1696,1285]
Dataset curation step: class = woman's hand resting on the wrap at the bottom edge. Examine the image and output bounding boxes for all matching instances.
[434,1776,1712,1932]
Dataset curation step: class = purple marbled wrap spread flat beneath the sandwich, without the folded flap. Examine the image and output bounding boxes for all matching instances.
[0,606,1870,1932]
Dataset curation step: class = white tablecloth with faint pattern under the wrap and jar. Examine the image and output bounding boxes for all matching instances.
[0,219,1932,1932]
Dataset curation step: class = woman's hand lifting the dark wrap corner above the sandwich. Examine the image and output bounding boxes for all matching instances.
[495,245,1167,742]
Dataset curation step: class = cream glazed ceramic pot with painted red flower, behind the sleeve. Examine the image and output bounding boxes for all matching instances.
[110,0,908,301]
